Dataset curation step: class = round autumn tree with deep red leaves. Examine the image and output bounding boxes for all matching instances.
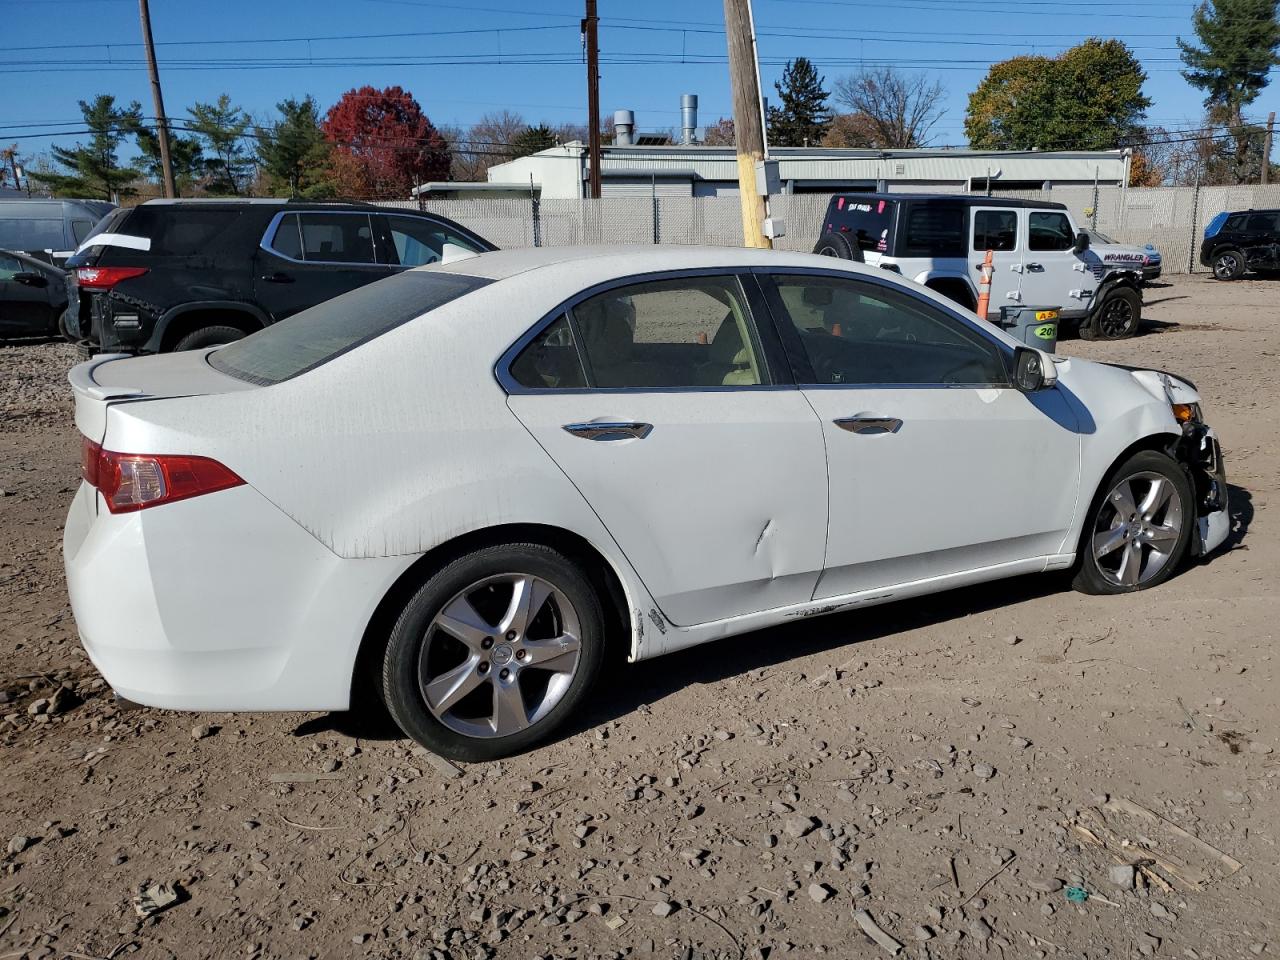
[323,86,449,200]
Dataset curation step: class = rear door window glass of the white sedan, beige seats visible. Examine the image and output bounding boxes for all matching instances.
[511,276,768,390]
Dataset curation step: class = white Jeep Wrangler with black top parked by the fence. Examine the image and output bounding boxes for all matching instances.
[813,193,1143,340]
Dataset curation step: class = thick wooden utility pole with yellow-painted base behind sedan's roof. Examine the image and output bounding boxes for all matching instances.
[724,0,773,248]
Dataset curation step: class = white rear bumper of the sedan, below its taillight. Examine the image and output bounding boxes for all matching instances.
[63,484,412,710]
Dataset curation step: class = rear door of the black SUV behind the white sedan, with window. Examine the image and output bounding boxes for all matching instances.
[253,210,392,320]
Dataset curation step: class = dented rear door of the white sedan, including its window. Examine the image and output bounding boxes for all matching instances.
[499,273,827,626]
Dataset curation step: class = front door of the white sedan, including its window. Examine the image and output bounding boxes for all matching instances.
[762,271,1080,599]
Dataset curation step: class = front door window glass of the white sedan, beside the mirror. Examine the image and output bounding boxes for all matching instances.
[774,276,1009,387]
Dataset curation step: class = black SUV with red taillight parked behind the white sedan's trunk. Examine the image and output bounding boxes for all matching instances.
[65,200,497,353]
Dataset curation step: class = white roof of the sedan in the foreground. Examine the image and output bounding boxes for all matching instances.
[416,243,883,280]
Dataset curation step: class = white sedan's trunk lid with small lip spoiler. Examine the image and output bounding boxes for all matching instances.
[67,348,260,443]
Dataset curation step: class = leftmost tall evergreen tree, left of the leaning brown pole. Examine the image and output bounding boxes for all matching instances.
[38,93,142,200]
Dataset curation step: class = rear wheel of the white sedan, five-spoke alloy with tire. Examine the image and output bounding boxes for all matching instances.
[384,544,603,760]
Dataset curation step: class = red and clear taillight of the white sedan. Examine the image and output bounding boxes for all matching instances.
[81,438,244,513]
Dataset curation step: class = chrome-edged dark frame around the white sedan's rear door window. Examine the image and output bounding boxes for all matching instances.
[493,266,797,397]
